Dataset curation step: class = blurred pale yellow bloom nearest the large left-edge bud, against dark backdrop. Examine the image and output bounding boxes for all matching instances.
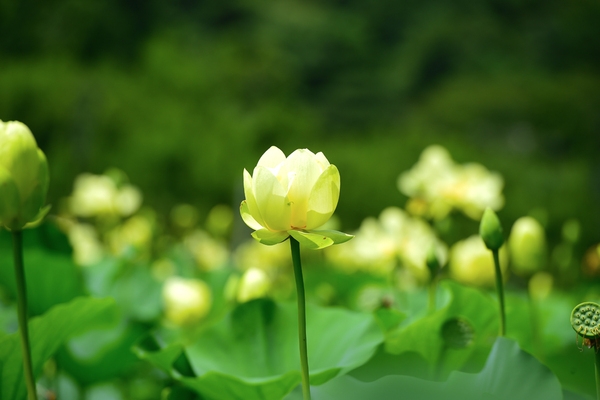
[69,173,142,217]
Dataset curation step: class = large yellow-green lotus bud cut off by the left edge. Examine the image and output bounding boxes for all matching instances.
[0,121,49,230]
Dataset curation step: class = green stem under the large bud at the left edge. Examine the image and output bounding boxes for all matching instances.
[12,230,37,400]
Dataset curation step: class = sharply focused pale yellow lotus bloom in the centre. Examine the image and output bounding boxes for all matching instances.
[240,146,352,249]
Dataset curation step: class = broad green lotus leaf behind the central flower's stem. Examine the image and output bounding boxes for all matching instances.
[138,300,383,400]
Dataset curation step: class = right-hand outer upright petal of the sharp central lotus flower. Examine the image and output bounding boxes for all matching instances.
[306,165,340,230]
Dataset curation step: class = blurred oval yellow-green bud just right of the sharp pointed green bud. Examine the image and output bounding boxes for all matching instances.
[508,217,547,276]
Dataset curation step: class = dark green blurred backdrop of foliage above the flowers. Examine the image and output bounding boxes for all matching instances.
[0,0,600,247]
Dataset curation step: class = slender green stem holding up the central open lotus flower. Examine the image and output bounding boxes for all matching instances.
[290,236,310,400]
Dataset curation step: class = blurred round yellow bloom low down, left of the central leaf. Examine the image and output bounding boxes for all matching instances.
[163,277,212,326]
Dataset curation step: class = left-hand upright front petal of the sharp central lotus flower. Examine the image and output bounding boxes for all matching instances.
[252,167,291,231]
